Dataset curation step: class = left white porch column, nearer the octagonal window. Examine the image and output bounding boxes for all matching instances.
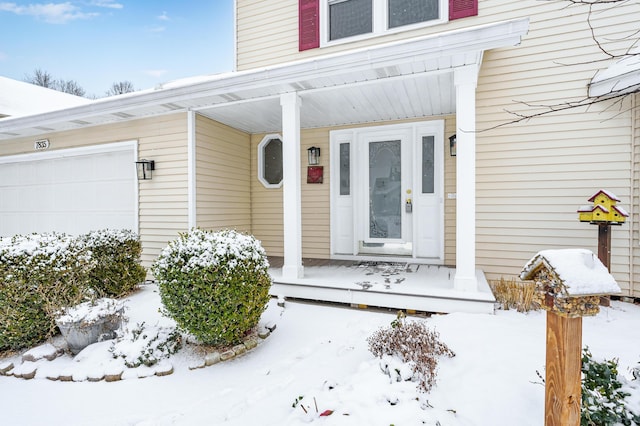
[280,93,304,278]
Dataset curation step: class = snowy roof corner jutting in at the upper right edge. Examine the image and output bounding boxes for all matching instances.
[589,46,640,97]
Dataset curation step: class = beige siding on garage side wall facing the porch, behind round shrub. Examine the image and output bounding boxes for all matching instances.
[196,115,251,232]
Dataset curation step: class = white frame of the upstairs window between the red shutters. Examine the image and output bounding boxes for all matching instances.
[319,0,449,48]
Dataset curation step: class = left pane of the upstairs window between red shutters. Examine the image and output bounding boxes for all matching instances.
[329,0,373,40]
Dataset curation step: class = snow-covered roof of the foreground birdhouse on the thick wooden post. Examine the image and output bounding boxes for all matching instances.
[521,249,621,296]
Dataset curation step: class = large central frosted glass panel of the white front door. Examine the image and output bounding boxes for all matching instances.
[369,140,402,239]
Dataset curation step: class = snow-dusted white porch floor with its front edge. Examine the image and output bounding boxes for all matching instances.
[269,257,495,313]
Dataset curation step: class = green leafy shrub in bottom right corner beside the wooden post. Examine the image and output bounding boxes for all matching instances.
[580,348,640,426]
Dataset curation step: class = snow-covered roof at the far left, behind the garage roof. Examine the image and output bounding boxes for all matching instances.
[0,76,92,118]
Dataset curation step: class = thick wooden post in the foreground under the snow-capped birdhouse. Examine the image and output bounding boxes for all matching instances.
[544,311,582,426]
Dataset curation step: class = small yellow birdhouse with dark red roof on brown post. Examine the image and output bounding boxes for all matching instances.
[578,189,629,271]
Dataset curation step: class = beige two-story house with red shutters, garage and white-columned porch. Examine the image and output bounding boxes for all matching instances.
[0,0,640,312]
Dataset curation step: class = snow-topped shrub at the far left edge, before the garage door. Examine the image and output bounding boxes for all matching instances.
[0,233,91,350]
